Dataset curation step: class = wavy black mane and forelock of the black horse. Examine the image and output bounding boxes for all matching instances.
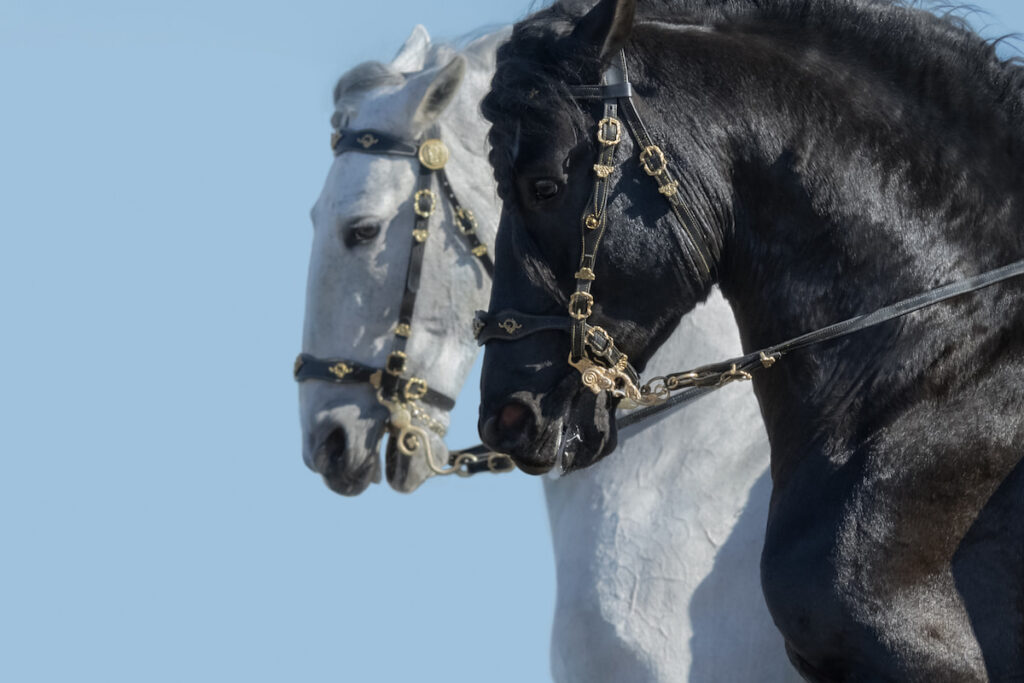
[482,0,1024,187]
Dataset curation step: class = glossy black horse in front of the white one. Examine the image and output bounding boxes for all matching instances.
[480,0,1024,682]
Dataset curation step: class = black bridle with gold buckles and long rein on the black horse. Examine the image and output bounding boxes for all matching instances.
[474,51,1024,417]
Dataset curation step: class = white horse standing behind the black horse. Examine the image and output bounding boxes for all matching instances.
[300,27,799,683]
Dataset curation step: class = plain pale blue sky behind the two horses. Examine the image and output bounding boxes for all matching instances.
[6,0,1024,683]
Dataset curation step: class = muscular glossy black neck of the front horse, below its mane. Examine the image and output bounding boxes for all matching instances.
[641,21,1024,481]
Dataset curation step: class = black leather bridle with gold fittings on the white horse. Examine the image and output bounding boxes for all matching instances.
[293,127,515,476]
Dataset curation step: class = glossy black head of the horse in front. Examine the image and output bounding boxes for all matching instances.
[480,0,713,472]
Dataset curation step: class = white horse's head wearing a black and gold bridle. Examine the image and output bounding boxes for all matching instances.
[296,27,498,496]
